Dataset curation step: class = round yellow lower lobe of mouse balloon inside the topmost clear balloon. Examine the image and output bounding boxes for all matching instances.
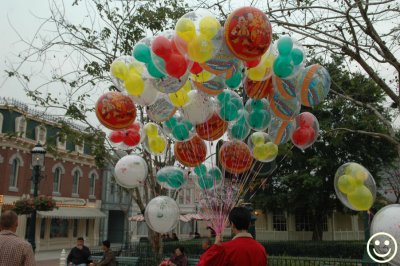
[188,34,214,63]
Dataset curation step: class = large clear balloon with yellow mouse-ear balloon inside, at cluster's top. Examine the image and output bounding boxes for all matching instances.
[174,9,223,63]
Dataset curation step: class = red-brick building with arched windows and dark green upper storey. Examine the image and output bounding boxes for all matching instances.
[0,98,105,251]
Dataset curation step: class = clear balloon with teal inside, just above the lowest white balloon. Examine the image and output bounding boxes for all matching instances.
[156,166,186,189]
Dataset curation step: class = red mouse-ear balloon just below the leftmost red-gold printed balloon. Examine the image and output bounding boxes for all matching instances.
[108,122,143,148]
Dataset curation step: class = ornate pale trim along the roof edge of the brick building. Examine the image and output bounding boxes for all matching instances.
[0,97,86,131]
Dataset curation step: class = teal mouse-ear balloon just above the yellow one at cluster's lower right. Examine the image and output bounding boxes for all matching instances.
[244,99,272,131]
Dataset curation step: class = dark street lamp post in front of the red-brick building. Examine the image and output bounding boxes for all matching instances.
[28,143,46,252]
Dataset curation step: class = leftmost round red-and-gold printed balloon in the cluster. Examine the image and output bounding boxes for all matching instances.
[95,91,136,130]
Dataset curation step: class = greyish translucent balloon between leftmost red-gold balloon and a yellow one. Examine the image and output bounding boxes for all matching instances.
[147,94,176,122]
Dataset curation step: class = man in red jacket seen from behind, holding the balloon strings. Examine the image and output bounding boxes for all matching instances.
[197,207,267,266]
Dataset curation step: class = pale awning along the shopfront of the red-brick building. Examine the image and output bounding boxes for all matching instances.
[38,208,106,219]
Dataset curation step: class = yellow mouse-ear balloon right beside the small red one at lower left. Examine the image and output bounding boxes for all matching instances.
[144,123,167,155]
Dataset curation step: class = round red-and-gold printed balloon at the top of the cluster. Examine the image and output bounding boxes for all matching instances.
[224,7,272,61]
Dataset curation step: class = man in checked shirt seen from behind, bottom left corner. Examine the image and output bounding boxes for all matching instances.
[0,211,36,266]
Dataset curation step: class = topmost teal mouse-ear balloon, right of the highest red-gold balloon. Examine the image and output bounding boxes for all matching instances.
[273,36,305,78]
